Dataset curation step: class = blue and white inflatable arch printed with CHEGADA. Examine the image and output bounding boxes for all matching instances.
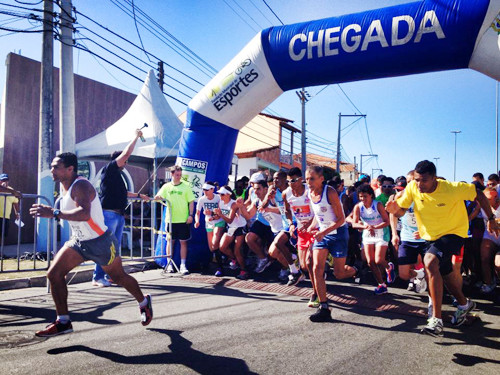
[157,0,500,268]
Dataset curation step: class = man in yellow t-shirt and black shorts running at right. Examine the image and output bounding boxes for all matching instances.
[386,160,500,336]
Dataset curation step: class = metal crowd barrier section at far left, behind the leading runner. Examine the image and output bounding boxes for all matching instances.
[0,193,57,273]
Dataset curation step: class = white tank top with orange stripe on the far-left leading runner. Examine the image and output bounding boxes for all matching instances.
[61,177,108,241]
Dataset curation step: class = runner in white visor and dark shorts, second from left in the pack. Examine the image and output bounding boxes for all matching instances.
[214,185,249,280]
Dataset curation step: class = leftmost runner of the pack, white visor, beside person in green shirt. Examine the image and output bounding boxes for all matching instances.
[194,181,226,276]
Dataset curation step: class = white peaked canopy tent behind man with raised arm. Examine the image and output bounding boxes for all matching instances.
[76,70,183,164]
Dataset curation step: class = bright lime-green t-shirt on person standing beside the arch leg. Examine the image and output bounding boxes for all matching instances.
[158,181,194,223]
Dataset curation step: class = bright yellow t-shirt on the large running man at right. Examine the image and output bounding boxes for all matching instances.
[397,180,476,241]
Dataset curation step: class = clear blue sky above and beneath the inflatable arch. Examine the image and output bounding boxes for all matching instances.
[0,0,496,181]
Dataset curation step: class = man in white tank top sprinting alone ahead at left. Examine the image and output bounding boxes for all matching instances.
[30,152,153,337]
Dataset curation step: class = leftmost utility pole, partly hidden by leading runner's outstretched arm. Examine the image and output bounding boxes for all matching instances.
[37,0,54,250]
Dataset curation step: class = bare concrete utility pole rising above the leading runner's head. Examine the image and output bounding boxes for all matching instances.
[59,0,76,152]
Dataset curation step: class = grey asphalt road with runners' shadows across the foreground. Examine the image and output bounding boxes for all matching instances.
[0,270,500,375]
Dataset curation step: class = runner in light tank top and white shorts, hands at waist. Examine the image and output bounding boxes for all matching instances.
[352,185,396,295]
